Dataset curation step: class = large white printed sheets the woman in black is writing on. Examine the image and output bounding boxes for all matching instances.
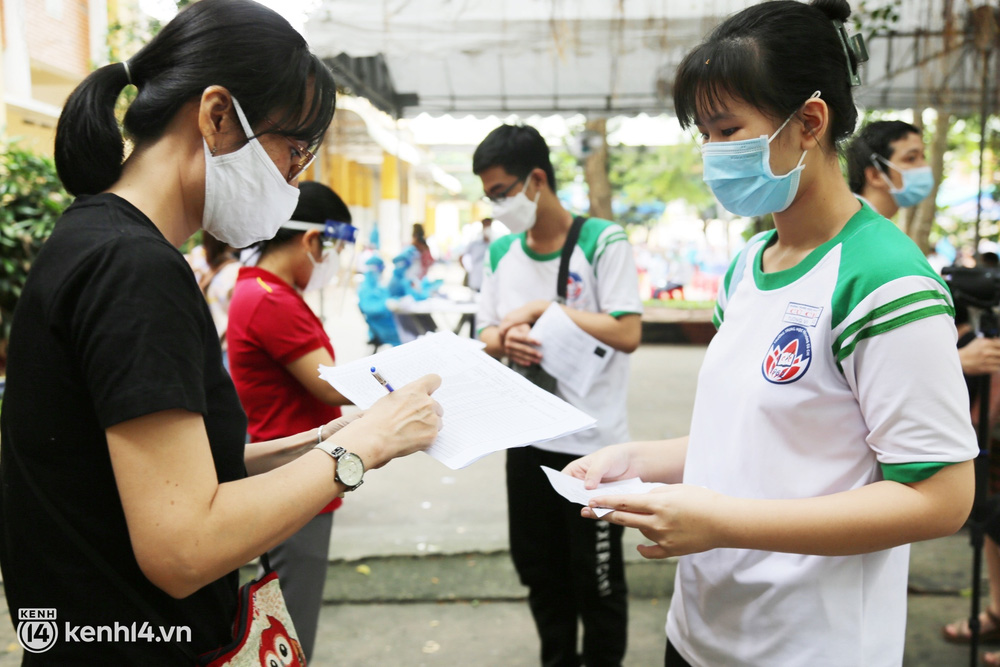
[319,332,596,470]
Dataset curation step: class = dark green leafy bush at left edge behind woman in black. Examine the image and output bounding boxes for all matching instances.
[0,143,69,340]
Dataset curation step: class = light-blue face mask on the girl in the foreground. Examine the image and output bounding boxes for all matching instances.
[701,91,819,216]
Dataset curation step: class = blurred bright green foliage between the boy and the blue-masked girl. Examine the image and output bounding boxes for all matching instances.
[609,141,715,223]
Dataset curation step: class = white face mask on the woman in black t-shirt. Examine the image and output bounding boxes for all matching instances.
[201,97,299,253]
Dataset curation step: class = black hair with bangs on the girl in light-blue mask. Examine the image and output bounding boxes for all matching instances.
[674,0,858,145]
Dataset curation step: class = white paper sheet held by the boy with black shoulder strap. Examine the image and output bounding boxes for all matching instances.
[531,303,615,396]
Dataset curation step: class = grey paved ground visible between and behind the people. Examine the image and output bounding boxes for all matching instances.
[0,280,1000,667]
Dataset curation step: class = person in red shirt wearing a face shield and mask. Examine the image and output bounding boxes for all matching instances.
[226,181,353,661]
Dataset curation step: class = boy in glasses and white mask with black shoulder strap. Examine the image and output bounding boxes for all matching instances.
[472,125,642,666]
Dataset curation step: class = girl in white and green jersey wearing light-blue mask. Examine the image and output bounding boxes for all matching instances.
[566,0,978,667]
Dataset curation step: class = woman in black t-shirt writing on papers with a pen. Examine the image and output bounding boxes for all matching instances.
[0,0,440,665]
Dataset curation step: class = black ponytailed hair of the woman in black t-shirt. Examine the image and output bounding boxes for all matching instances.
[55,0,337,195]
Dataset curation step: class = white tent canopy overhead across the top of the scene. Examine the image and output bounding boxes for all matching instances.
[306,0,996,116]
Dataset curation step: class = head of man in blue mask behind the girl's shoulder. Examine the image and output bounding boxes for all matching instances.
[846,120,934,218]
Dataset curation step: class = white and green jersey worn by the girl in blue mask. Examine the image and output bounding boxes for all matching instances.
[667,205,978,665]
